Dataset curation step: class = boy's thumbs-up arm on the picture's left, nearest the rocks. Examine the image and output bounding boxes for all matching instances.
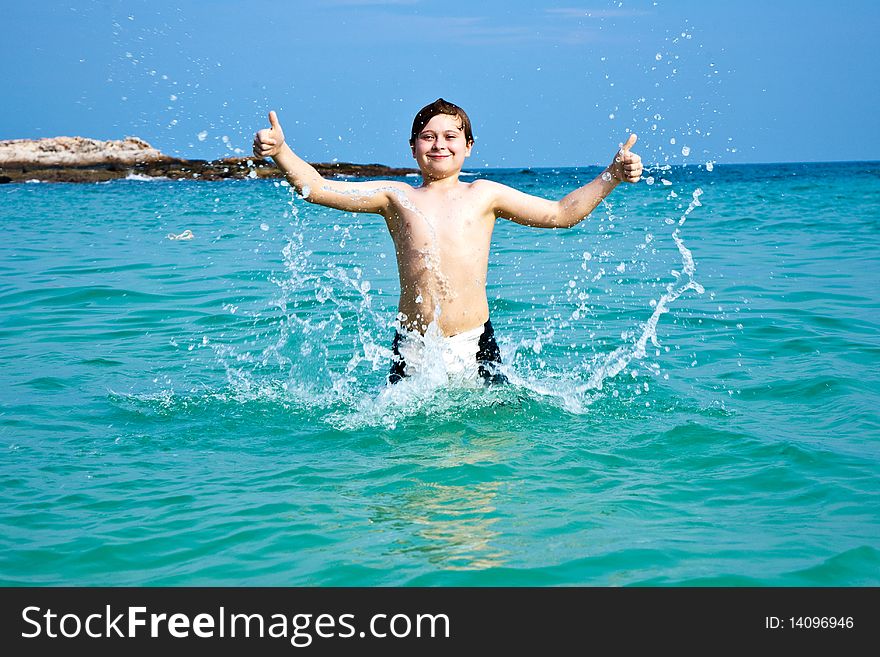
[254,111,399,215]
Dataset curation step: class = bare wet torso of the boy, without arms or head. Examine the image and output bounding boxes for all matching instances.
[386,182,495,335]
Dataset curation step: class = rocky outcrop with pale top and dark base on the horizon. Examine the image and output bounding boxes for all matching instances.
[0,137,418,183]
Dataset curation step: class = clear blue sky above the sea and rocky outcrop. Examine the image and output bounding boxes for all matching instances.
[0,0,880,168]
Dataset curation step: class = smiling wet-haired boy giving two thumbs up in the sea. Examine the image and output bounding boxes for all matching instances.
[254,98,642,383]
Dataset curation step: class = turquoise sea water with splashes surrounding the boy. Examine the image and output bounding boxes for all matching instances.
[0,163,880,586]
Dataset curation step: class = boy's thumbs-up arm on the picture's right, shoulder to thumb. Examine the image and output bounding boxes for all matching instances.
[495,134,642,228]
